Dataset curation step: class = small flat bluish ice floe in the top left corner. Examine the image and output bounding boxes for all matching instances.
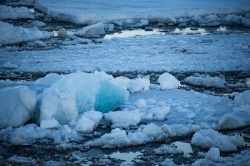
[0,5,34,20]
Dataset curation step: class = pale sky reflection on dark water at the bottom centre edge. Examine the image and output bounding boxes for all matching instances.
[109,152,142,165]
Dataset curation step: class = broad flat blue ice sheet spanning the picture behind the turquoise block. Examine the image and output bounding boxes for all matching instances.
[0,33,250,72]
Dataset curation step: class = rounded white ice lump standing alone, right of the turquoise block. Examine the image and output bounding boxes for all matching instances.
[158,73,180,90]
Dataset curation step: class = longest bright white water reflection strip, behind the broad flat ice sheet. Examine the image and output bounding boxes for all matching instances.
[104,29,164,39]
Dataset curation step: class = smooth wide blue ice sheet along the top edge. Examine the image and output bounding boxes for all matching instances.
[35,0,250,24]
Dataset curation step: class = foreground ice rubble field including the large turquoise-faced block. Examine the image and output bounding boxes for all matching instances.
[0,72,250,164]
